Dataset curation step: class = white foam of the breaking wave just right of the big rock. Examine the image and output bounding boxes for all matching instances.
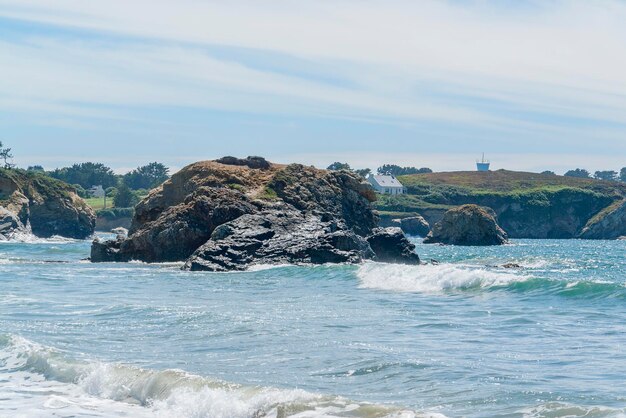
[357,262,530,294]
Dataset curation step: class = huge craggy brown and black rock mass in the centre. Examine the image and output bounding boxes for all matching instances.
[91,157,419,271]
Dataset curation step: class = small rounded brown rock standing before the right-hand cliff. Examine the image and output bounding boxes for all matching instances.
[424,205,507,245]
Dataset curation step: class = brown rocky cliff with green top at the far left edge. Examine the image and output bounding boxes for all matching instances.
[0,169,96,239]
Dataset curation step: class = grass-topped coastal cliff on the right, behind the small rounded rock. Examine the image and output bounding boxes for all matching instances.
[376,170,626,239]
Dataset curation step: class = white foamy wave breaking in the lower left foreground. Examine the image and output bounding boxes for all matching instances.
[0,336,442,418]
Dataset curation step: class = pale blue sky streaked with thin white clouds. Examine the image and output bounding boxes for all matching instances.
[0,0,626,173]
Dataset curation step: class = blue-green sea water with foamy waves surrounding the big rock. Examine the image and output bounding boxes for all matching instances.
[0,239,626,418]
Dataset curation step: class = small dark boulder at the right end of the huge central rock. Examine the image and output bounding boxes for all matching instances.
[367,228,420,264]
